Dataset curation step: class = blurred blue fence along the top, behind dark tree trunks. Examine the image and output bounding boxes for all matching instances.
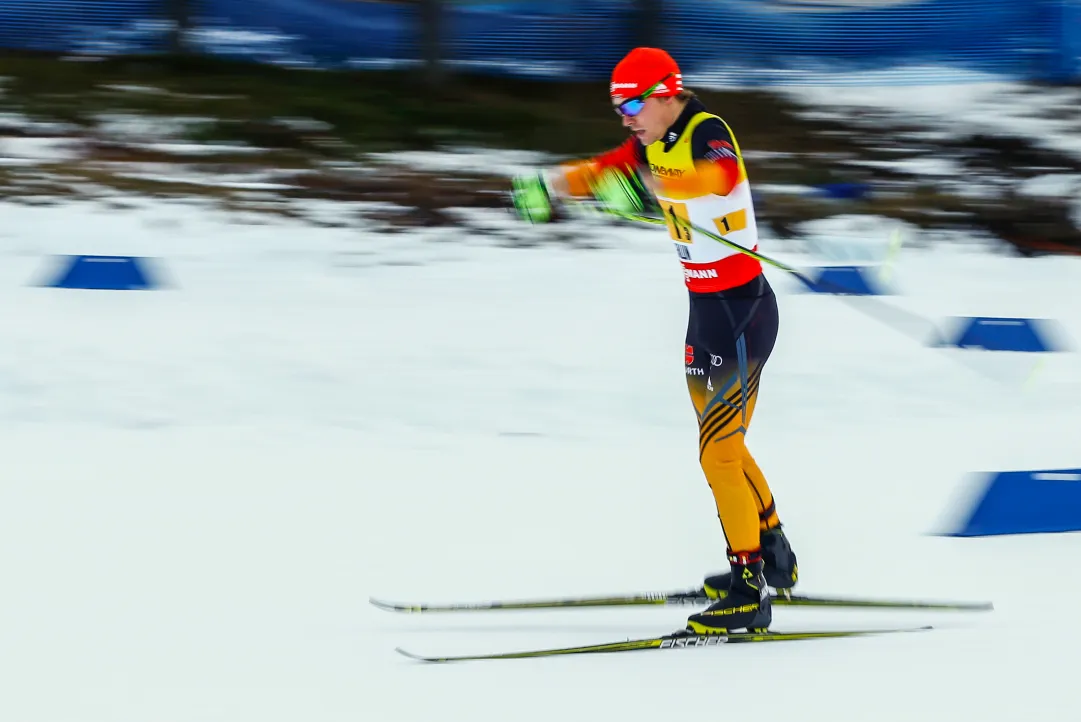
[0,0,1081,85]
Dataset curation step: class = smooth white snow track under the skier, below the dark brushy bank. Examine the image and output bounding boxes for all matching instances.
[0,197,1081,722]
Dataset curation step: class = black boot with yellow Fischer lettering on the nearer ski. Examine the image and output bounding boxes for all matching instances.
[686,551,773,634]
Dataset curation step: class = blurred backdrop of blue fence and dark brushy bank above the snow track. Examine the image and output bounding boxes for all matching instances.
[0,0,1081,254]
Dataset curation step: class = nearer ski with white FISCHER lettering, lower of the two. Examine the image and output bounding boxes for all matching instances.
[395,627,932,663]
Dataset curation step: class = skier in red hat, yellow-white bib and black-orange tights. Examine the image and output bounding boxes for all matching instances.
[512,48,798,634]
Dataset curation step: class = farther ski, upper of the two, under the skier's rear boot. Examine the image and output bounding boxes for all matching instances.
[369,589,995,614]
